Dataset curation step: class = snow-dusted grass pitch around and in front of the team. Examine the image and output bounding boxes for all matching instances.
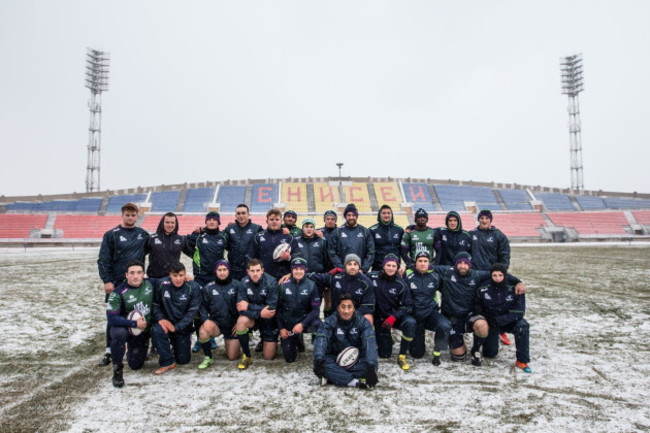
[0,245,650,432]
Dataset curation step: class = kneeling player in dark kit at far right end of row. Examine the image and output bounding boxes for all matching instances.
[472,263,531,373]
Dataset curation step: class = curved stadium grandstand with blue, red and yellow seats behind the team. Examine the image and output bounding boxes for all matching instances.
[0,178,650,246]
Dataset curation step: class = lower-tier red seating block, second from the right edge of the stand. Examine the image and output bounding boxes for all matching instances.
[547,212,630,235]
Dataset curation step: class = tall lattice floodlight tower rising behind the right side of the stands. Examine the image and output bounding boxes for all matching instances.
[560,54,585,191]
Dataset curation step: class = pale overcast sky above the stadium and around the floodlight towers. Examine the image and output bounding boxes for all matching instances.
[0,0,650,195]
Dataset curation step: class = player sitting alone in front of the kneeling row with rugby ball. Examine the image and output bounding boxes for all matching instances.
[314,293,378,389]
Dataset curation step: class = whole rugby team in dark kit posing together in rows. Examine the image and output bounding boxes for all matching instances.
[97,203,531,389]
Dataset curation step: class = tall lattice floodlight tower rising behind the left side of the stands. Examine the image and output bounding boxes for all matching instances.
[85,48,111,192]
